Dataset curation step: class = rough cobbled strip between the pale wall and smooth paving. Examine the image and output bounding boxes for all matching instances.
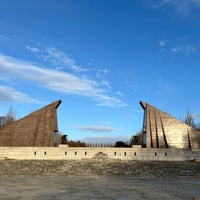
[0,159,200,176]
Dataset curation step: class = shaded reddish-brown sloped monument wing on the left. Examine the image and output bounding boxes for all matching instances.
[0,100,61,147]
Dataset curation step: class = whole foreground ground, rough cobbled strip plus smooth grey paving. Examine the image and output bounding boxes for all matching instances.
[0,159,200,200]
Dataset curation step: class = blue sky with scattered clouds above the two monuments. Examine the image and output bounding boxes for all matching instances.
[0,0,200,140]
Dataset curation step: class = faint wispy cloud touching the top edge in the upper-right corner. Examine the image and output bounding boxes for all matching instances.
[151,0,200,16]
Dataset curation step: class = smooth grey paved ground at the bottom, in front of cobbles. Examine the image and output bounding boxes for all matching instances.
[0,175,200,200]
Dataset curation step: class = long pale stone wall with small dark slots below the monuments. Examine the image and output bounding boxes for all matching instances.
[0,146,200,161]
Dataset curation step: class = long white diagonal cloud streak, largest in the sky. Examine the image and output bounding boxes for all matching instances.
[0,54,126,107]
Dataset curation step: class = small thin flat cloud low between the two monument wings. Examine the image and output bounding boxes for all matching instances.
[76,126,117,132]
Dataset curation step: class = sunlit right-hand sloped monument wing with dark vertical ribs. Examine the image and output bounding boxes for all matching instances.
[140,102,200,149]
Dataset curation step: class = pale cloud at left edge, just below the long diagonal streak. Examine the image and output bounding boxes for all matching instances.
[0,85,40,103]
